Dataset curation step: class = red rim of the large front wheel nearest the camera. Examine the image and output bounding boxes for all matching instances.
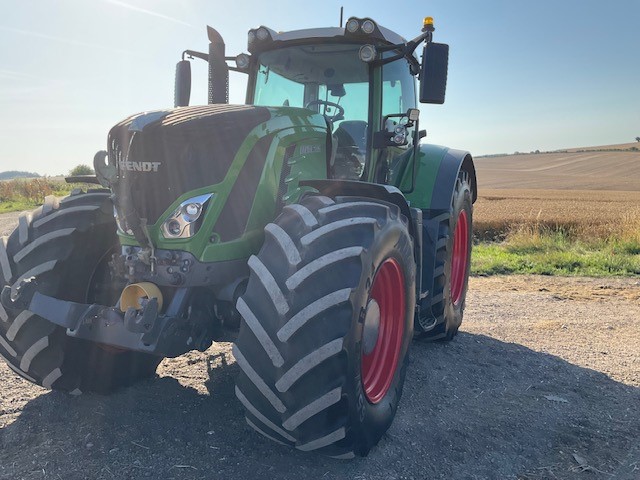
[361,258,406,403]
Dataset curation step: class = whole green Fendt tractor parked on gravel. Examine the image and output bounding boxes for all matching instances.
[0,17,477,458]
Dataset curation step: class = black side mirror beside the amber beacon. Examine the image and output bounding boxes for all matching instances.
[420,42,449,105]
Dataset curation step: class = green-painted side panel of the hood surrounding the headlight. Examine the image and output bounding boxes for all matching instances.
[118,107,327,262]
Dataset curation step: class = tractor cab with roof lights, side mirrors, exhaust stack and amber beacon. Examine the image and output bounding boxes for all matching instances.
[176,17,448,192]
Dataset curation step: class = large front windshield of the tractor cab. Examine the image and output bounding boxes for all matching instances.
[253,44,369,180]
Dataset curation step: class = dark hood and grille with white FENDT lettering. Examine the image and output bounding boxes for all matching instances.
[108,104,271,231]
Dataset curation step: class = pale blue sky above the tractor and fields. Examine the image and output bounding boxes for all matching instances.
[0,0,640,175]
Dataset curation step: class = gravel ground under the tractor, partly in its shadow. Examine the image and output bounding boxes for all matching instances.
[0,214,640,480]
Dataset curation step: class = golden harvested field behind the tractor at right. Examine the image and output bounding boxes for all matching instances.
[474,144,640,240]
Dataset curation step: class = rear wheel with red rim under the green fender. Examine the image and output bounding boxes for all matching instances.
[416,170,473,341]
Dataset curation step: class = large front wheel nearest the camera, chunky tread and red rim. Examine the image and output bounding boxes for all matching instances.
[233,196,415,458]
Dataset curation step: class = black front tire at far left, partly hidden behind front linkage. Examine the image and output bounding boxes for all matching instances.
[0,191,162,394]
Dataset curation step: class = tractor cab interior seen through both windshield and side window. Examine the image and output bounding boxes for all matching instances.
[252,43,416,180]
